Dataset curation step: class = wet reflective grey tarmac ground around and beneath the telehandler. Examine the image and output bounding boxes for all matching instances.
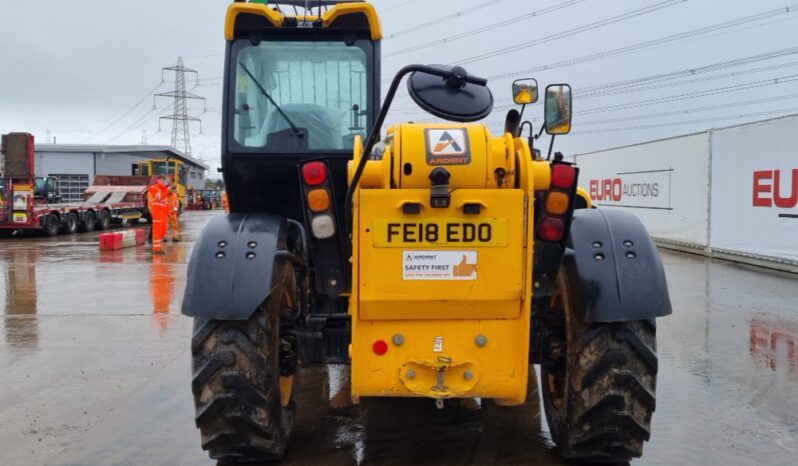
[0,212,798,466]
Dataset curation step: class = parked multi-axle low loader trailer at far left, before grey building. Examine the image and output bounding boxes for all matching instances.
[0,133,149,236]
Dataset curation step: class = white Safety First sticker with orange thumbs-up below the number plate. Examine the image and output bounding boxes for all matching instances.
[402,251,477,280]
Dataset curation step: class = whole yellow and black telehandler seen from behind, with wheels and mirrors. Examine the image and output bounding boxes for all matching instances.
[183,1,671,463]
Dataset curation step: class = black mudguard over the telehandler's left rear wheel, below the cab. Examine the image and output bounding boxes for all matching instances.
[182,214,289,320]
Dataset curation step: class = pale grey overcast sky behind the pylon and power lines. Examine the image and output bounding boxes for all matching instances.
[0,0,798,176]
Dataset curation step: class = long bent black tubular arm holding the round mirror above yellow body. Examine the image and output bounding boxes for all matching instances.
[344,65,488,233]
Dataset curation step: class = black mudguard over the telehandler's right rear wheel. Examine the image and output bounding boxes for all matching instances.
[564,209,672,322]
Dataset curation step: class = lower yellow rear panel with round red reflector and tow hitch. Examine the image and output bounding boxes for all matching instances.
[349,312,529,404]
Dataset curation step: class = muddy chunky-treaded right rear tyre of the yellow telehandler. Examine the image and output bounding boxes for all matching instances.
[541,271,657,463]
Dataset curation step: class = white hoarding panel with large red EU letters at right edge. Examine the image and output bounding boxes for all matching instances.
[711,116,798,262]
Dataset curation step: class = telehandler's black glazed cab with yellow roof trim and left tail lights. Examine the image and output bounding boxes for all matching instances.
[216,1,382,332]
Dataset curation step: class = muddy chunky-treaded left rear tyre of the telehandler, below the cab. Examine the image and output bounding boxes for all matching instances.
[191,267,297,463]
